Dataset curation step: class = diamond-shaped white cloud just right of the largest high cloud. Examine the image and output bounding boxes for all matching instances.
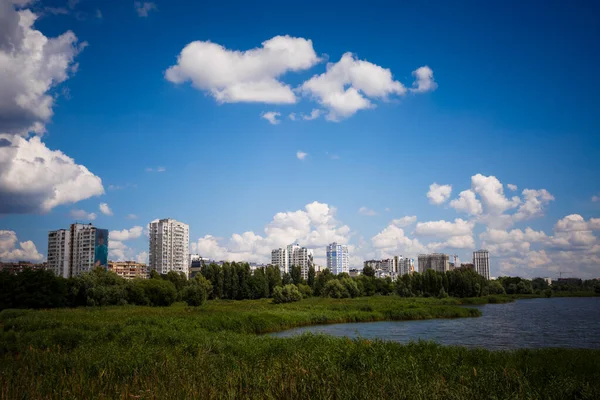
[300,53,406,121]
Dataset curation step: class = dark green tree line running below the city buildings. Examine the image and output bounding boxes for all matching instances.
[0,262,600,310]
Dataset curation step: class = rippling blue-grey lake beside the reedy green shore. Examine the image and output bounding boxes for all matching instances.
[271,297,600,350]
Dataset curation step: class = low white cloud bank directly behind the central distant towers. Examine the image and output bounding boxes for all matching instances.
[190,202,350,264]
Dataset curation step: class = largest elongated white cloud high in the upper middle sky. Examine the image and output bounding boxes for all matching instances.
[165,35,320,104]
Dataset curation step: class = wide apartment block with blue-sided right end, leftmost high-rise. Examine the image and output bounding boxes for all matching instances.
[48,224,108,278]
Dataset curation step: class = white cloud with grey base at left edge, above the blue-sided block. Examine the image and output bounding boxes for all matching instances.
[0,135,104,214]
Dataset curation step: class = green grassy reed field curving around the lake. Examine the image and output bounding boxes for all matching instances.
[0,296,600,399]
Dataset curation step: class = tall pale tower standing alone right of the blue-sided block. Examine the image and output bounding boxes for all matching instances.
[148,218,190,277]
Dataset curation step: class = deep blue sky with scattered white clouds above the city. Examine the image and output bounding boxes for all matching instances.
[0,0,600,277]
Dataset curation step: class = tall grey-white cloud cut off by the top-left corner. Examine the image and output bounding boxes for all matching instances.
[0,6,85,135]
